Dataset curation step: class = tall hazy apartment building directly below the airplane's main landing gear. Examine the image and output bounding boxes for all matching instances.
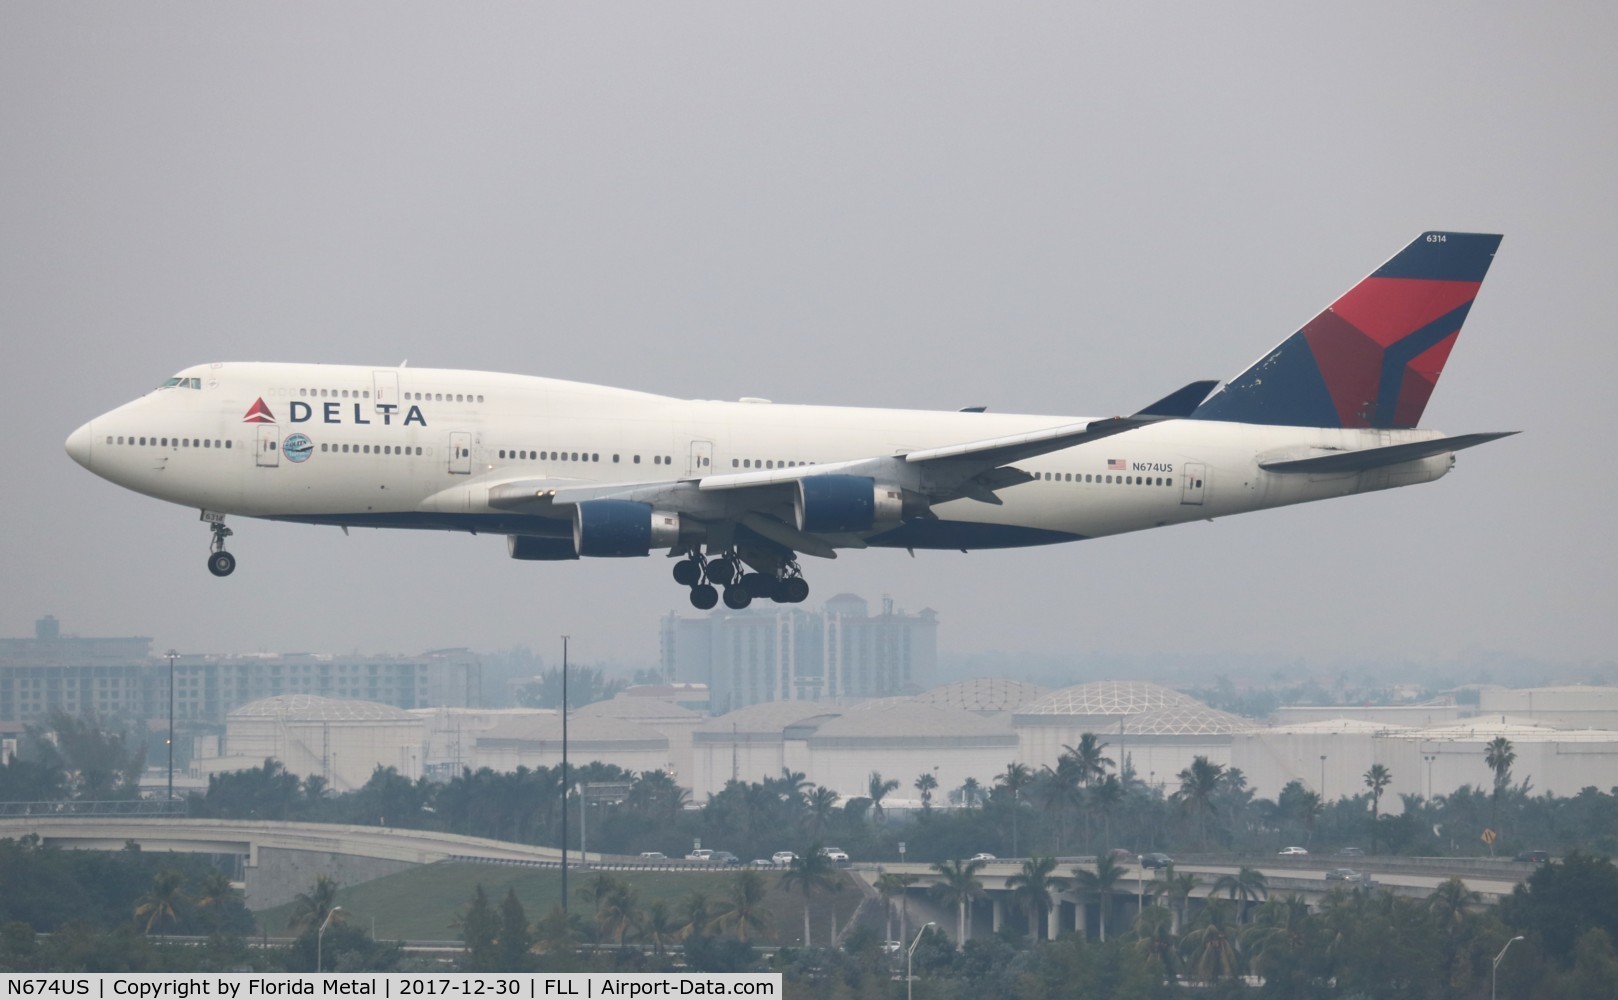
[660,594,938,715]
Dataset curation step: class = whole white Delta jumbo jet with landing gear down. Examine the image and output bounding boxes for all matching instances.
[66,231,1514,608]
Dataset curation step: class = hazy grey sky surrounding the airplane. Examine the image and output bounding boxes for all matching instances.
[0,2,1618,662]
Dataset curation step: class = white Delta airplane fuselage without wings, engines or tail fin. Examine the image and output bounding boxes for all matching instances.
[70,362,1453,549]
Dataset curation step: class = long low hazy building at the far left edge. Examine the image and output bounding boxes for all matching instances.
[0,615,482,731]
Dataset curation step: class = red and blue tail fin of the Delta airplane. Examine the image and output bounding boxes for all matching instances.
[1191,233,1500,427]
